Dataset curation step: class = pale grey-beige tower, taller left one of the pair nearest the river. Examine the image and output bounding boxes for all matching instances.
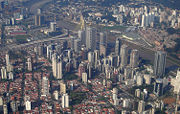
[120,44,128,67]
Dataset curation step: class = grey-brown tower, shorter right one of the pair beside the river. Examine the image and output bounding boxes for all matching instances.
[130,49,139,68]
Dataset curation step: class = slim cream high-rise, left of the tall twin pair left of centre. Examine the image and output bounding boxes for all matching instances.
[52,53,57,78]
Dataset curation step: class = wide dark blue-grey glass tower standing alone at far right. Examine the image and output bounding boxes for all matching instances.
[154,51,166,78]
